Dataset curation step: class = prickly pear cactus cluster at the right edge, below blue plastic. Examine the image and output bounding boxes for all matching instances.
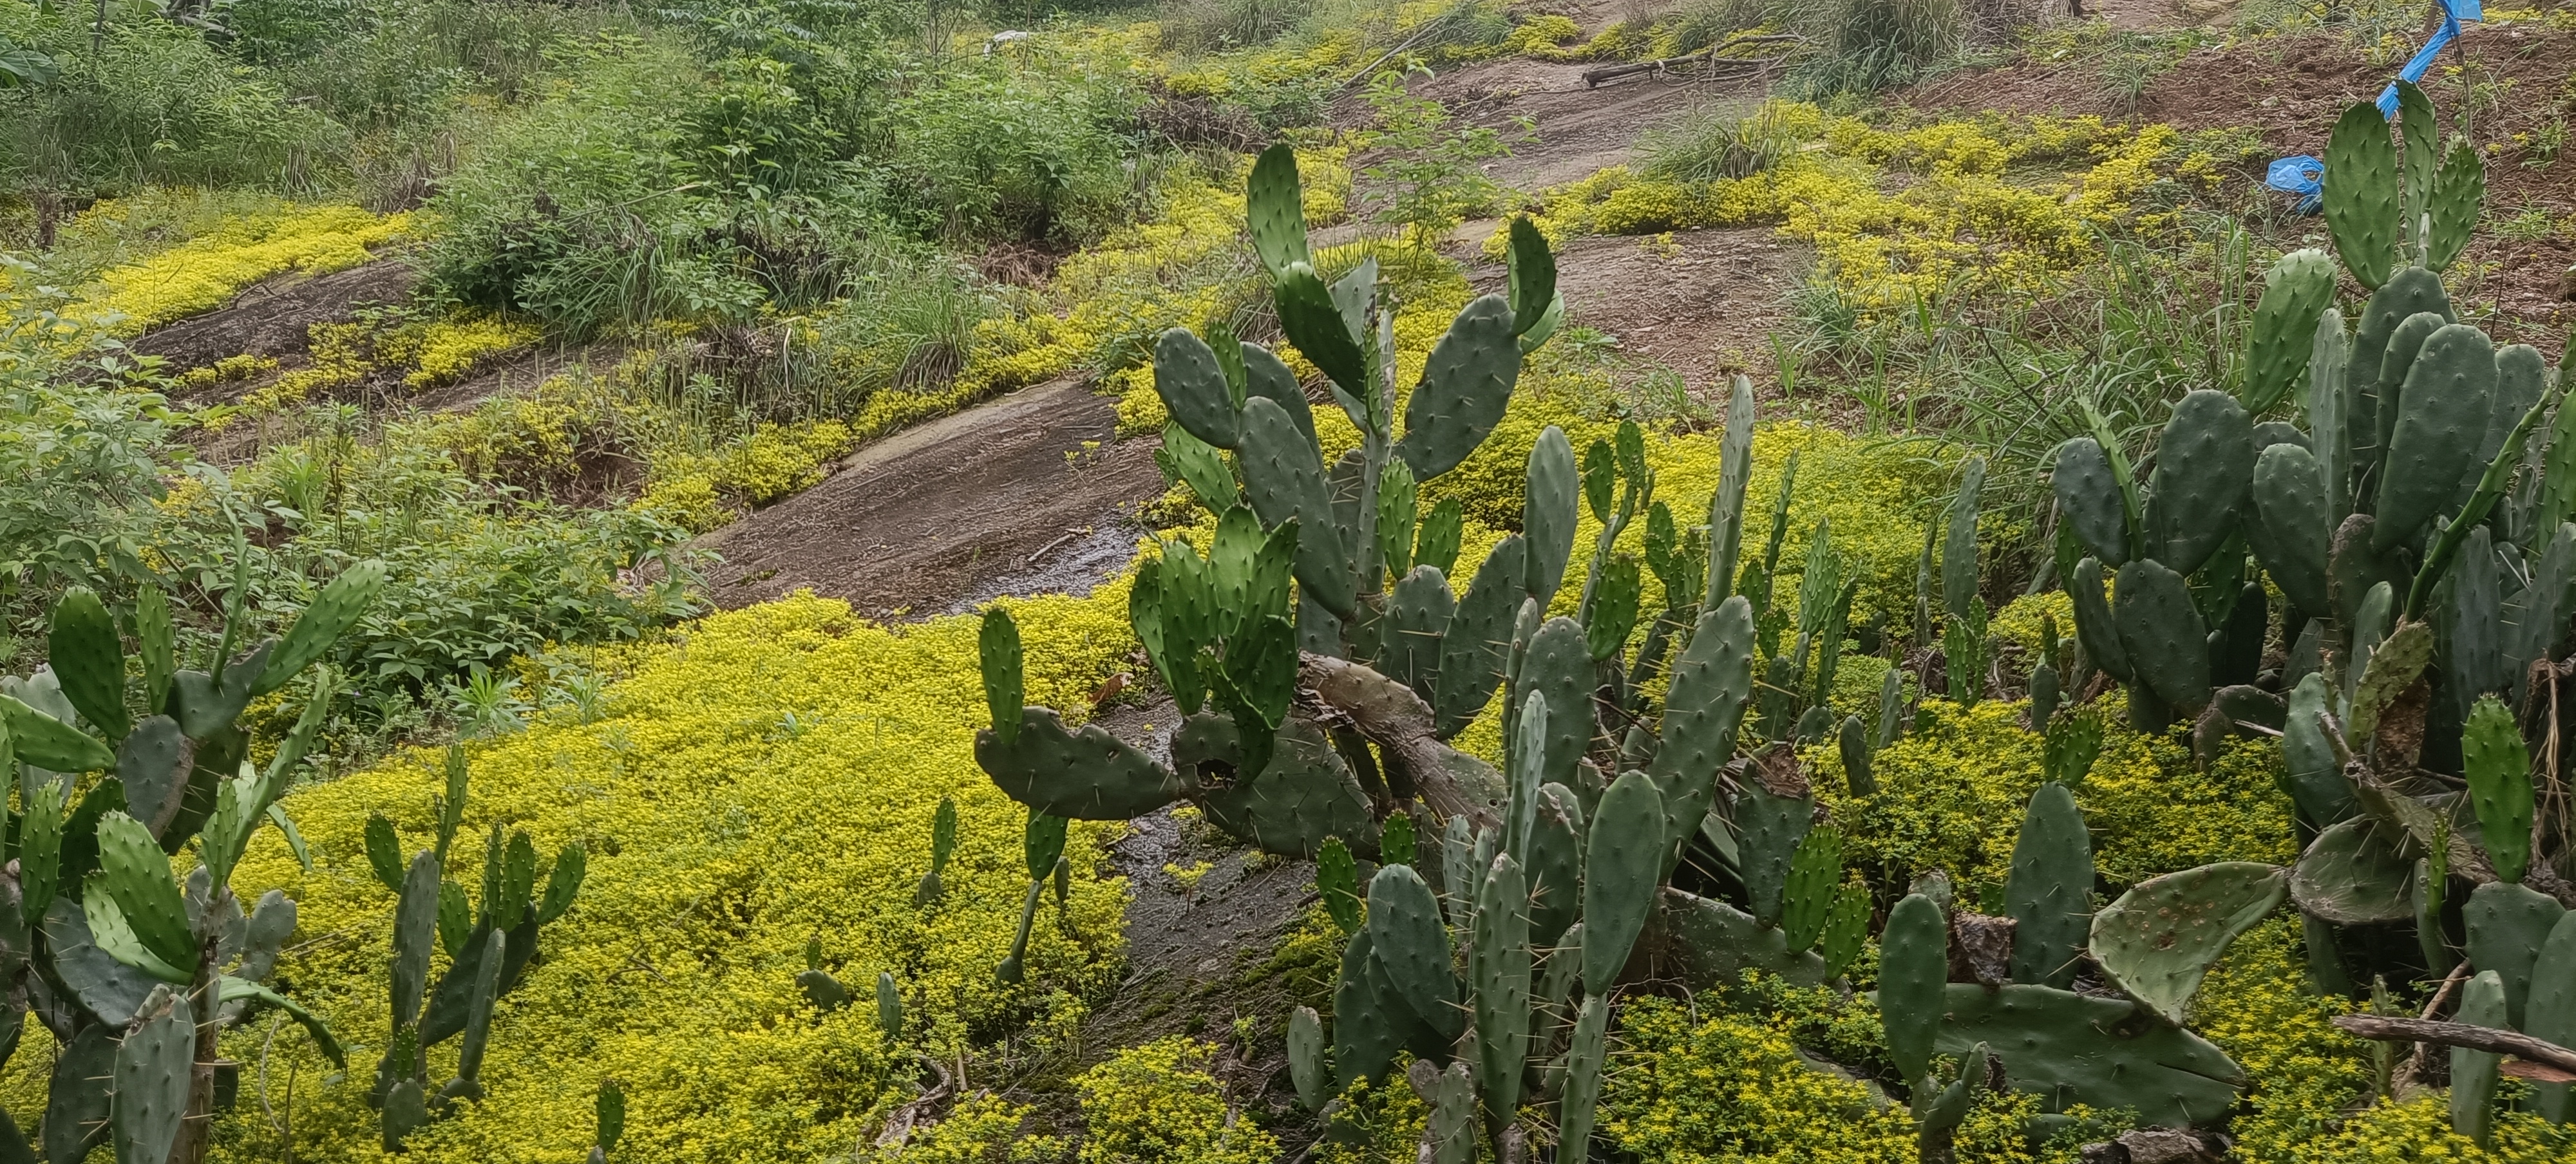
[2009,85,2576,1141]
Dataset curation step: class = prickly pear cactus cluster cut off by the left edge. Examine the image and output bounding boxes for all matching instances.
[0,561,384,1164]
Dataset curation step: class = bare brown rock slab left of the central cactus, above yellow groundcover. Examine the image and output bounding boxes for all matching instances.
[701,379,1162,618]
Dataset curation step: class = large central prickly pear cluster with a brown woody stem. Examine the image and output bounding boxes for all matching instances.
[976,149,1937,1161]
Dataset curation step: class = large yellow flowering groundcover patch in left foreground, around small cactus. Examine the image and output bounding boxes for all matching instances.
[0,592,1133,1164]
